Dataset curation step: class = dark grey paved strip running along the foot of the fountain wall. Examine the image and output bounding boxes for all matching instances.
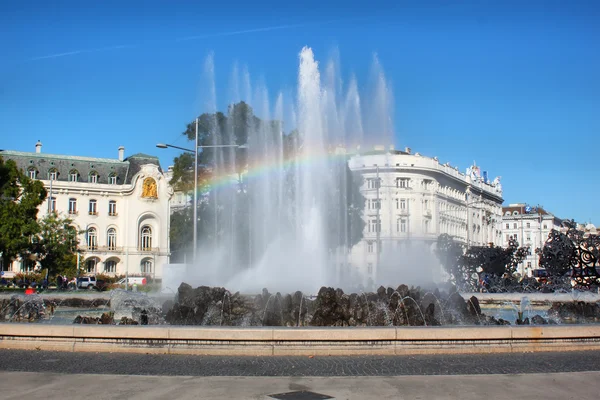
[0,350,600,377]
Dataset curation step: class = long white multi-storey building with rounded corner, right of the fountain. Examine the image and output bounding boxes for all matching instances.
[349,146,503,280]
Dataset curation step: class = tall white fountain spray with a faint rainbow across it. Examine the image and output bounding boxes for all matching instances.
[179,47,392,293]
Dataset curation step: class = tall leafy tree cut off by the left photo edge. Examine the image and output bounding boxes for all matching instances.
[0,157,47,265]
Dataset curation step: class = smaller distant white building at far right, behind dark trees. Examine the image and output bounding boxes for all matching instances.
[502,203,562,276]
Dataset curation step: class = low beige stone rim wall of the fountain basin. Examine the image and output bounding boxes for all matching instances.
[0,323,600,356]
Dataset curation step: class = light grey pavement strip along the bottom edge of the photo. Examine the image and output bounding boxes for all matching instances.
[0,371,600,400]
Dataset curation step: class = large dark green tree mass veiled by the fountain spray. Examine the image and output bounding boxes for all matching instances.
[170,102,365,263]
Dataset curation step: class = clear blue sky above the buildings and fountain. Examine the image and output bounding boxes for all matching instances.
[0,0,600,225]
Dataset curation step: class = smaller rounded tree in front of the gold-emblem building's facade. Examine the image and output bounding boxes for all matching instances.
[33,213,79,275]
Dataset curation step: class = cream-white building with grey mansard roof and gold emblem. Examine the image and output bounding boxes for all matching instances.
[0,142,172,279]
